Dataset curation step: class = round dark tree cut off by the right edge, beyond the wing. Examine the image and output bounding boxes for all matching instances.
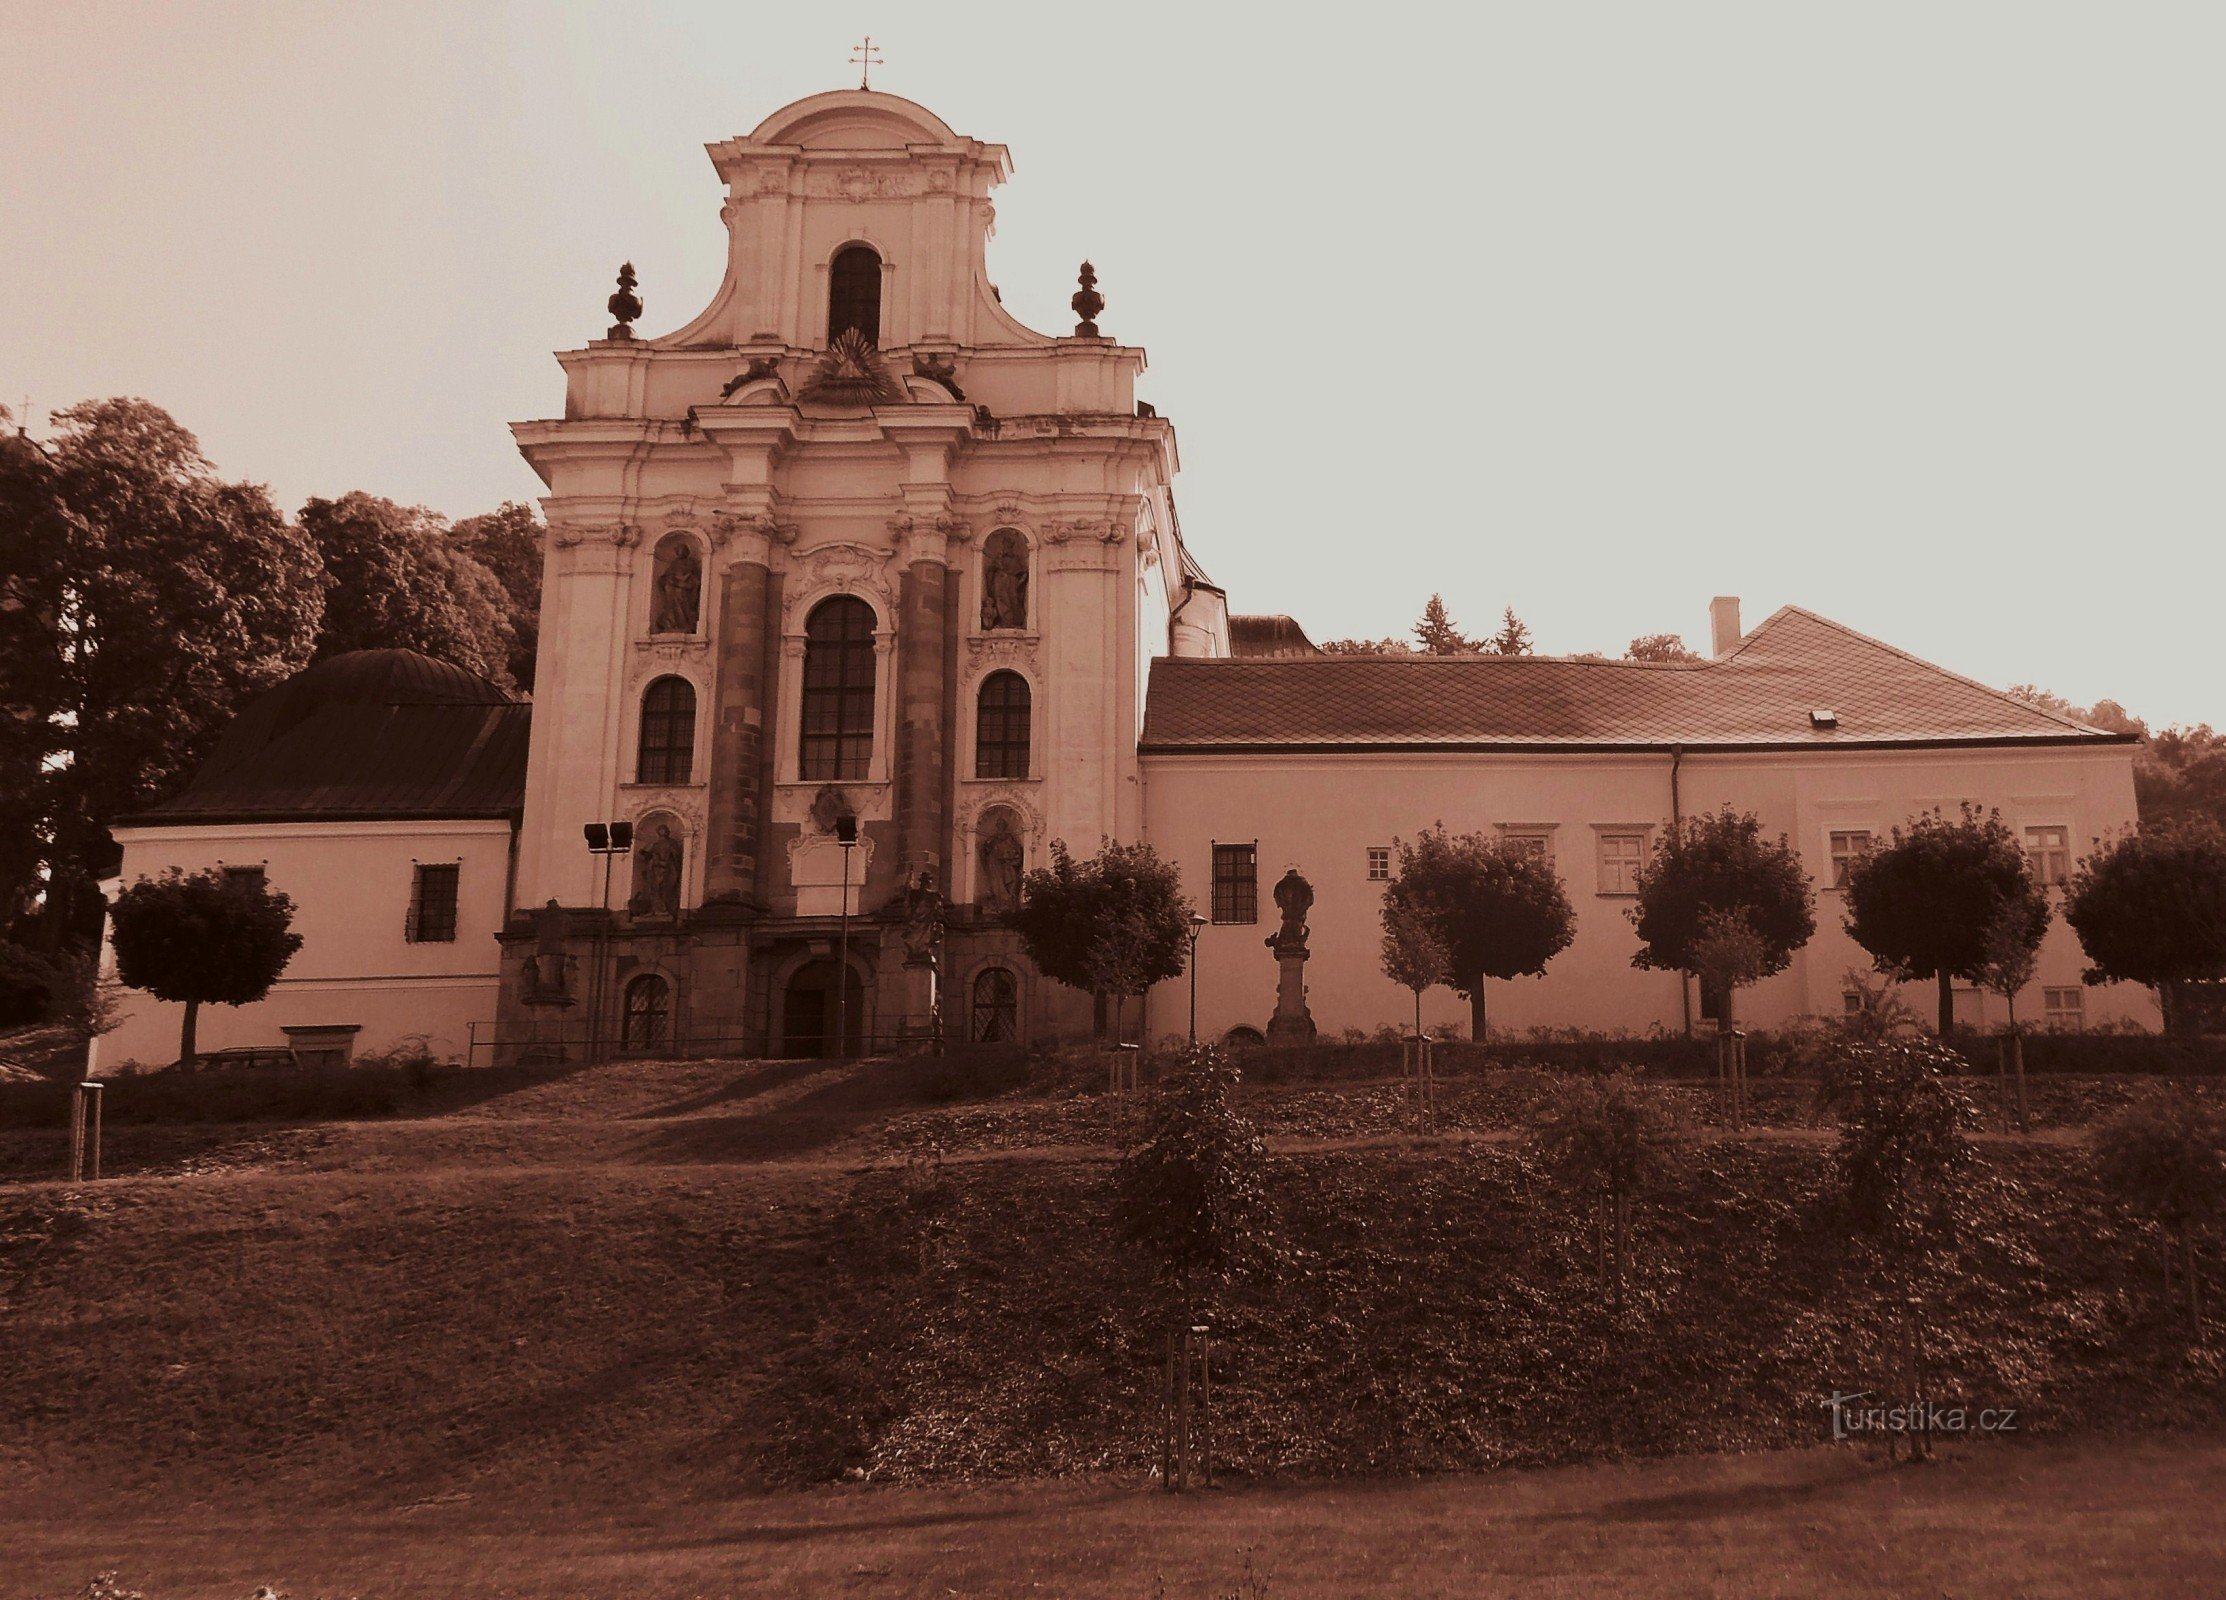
[2064,819,2226,1033]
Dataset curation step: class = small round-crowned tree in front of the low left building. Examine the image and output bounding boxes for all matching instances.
[109,868,301,1066]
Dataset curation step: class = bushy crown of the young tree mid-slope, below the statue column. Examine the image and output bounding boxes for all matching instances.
[1120,1044,1273,1293]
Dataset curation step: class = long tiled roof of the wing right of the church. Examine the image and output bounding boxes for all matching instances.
[1142,605,2119,752]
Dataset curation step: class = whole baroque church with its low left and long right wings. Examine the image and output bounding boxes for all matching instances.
[102,89,2153,1061]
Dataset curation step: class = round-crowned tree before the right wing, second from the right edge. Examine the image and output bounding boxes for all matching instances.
[1848,803,2048,1039]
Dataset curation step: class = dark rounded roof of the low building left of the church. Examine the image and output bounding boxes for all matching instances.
[131,650,532,823]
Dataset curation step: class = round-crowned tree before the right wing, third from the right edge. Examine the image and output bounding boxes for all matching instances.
[1629,806,1816,1028]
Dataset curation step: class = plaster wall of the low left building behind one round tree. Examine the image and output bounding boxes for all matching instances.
[93,821,510,1070]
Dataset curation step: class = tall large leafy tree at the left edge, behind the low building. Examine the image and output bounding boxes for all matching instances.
[0,398,325,950]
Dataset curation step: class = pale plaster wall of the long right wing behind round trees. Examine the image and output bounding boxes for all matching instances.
[1144,745,2157,1037]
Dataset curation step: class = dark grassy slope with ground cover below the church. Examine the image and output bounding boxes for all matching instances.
[0,1068,2226,1504]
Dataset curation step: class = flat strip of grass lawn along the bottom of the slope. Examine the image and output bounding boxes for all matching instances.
[0,1438,2226,1600]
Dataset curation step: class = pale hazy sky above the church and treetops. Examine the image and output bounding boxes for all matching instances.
[0,0,2226,725]
